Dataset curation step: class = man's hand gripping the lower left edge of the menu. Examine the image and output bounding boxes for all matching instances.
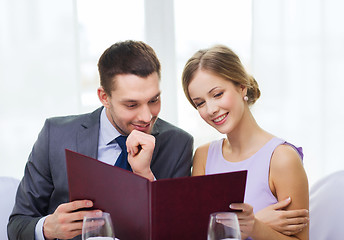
[43,200,102,240]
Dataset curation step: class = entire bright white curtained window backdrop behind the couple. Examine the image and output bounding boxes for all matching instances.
[0,0,344,188]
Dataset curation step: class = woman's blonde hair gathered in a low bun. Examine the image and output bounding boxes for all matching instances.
[182,45,260,108]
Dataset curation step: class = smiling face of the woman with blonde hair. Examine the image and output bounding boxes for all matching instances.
[188,70,246,134]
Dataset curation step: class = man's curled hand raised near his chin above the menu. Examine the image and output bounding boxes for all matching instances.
[126,130,155,181]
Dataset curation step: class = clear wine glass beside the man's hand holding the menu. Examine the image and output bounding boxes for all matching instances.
[82,212,115,240]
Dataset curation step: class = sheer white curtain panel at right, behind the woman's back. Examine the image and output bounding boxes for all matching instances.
[252,0,344,184]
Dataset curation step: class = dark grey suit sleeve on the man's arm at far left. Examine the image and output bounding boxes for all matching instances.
[7,120,53,240]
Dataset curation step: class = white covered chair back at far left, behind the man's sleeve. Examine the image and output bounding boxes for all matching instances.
[0,177,20,239]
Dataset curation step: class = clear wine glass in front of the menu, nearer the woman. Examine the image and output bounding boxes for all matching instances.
[208,212,241,240]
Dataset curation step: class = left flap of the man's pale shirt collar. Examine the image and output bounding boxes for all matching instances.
[99,108,121,145]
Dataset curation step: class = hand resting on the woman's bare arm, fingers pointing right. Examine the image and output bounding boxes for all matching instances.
[256,198,309,235]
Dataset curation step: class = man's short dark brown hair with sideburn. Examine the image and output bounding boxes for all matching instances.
[98,40,161,96]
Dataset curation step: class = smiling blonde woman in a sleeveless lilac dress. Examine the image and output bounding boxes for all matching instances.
[182,45,309,240]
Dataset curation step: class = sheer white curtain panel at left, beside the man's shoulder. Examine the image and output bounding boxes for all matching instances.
[0,0,79,178]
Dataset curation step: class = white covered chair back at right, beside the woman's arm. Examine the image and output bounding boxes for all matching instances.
[309,171,344,240]
